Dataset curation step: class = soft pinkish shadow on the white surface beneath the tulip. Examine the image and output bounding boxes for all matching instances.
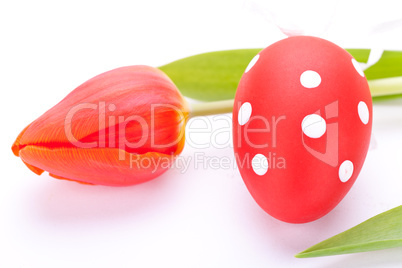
[27,168,180,224]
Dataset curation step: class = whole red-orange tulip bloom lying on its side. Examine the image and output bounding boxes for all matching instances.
[12,66,188,186]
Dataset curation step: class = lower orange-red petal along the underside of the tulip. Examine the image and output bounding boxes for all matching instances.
[19,145,175,186]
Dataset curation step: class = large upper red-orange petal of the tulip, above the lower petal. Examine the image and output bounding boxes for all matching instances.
[13,65,188,156]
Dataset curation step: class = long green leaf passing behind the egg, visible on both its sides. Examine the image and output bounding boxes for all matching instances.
[159,49,402,101]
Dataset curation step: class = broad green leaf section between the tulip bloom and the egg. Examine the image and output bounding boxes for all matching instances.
[159,49,261,101]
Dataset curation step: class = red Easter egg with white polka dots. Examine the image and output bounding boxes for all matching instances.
[233,36,372,223]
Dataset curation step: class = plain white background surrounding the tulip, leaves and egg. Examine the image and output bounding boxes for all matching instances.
[0,0,402,268]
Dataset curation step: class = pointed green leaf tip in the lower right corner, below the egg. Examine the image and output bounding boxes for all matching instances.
[295,206,402,258]
